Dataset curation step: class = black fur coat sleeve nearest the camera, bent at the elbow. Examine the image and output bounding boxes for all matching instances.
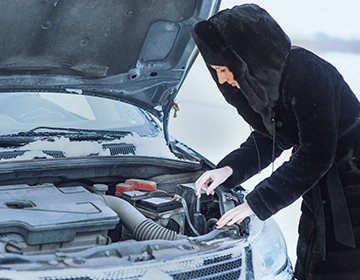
[246,59,339,220]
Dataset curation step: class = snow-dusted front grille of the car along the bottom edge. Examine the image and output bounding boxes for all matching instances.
[2,242,248,280]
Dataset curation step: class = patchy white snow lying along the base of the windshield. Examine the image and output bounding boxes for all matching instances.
[0,133,176,161]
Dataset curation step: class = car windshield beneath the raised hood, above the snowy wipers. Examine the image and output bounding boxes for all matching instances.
[0,92,159,136]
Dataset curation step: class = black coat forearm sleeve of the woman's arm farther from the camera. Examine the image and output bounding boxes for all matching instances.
[217,131,283,188]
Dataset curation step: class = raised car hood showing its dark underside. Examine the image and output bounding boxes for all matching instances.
[0,0,220,121]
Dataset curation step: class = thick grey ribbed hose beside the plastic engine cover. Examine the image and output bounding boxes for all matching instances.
[97,195,186,241]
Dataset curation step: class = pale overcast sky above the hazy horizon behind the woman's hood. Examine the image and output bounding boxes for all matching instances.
[221,0,360,39]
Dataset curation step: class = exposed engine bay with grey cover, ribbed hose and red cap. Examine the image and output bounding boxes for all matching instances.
[0,179,248,255]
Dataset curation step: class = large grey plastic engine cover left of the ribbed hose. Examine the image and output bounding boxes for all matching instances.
[0,184,119,254]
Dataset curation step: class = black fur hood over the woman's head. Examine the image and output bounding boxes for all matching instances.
[192,4,291,135]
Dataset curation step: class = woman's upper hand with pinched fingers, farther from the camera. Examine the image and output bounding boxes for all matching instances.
[195,166,233,198]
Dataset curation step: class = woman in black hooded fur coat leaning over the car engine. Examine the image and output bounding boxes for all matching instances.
[192,4,360,280]
